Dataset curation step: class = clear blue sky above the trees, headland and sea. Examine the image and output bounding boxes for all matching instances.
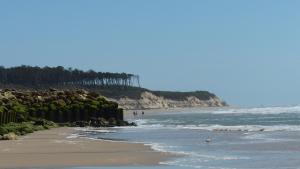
[0,0,300,105]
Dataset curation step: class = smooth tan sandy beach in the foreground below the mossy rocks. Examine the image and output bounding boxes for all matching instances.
[0,127,171,168]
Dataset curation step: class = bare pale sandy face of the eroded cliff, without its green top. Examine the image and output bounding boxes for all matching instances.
[109,92,226,109]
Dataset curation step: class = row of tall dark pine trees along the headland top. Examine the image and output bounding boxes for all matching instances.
[0,65,140,87]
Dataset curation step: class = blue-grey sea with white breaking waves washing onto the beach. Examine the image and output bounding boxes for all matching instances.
[69,106,300,169]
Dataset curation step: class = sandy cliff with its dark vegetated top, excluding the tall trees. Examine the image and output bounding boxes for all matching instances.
[0,85,228,110]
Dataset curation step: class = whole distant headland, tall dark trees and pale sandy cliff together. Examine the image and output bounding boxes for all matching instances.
[0,65,227,109]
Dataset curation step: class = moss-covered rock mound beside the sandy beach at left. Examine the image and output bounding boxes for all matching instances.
[0,89,123,125]
